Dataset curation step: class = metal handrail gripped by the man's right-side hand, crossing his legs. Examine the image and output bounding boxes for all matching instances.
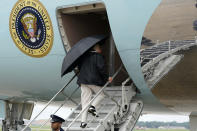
[65,64,123,131]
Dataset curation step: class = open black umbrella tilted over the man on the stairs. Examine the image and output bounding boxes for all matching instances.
[61,35,106,77]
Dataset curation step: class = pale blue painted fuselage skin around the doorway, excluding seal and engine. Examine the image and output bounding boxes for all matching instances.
[0,0,197,118]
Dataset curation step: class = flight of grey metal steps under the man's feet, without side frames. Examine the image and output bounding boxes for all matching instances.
[63,86,137,131]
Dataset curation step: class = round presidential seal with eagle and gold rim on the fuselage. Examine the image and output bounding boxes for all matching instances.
[10,0,53,57]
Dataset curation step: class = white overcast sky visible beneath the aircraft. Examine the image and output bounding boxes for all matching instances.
[32,104,189,122]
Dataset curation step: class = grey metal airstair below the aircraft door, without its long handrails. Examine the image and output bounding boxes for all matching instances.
[64,78,143,131]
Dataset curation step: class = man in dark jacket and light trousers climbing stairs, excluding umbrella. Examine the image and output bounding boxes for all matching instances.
[77,44,112,128]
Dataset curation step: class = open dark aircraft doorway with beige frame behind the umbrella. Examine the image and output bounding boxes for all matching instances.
[57,3,128,86]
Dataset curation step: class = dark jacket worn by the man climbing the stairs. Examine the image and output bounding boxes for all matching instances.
[77,52,108,86]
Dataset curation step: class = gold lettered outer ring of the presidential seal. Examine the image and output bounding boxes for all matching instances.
[9,0,54,58]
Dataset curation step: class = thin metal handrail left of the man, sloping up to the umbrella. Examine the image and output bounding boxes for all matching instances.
[22,73,78,131]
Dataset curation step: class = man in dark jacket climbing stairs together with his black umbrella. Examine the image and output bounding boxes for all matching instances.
[61,35,112,128]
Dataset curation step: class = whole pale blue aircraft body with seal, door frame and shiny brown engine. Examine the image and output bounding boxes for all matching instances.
[0,0,197,131]
